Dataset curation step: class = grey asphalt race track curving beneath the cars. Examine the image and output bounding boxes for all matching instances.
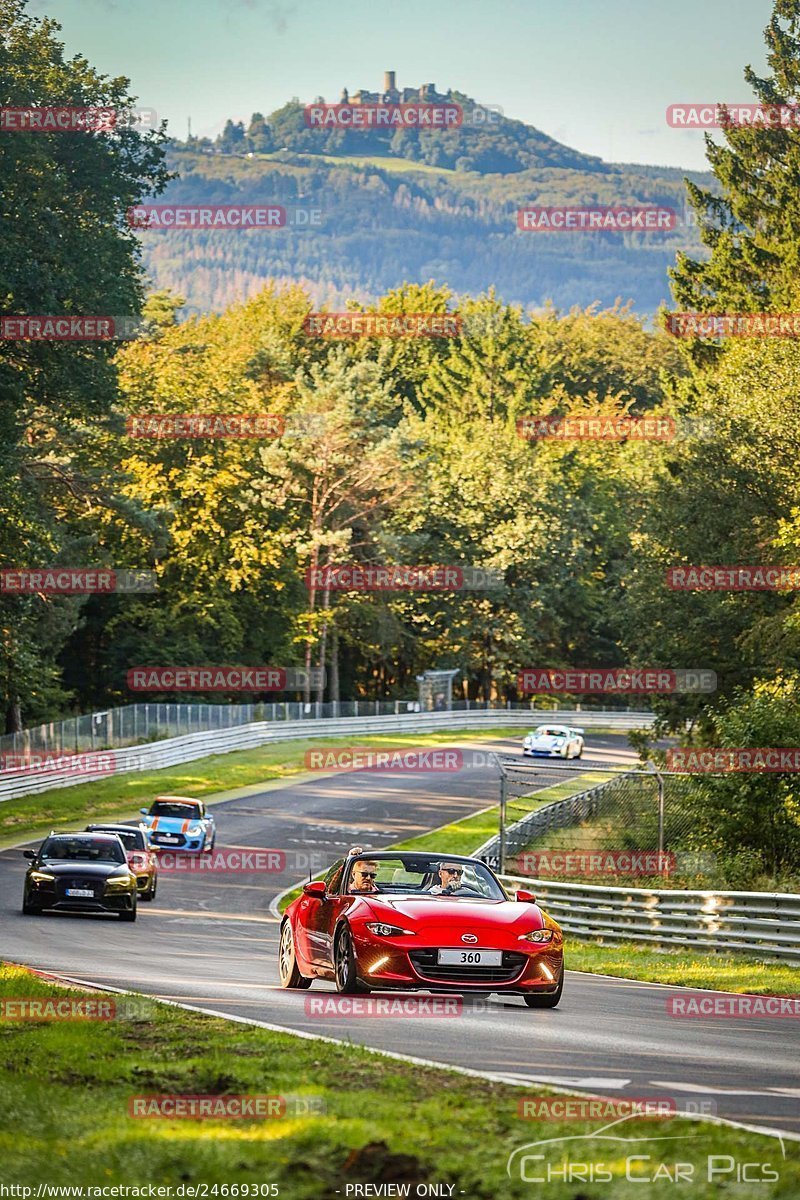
[0,734,800,1136]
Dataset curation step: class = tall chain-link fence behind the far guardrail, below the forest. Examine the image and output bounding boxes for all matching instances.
[0,697,646,755]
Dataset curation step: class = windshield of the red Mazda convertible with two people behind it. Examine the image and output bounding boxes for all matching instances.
[347,854,506,900]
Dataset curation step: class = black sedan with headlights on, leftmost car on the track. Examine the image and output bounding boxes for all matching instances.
[23,833,137,920]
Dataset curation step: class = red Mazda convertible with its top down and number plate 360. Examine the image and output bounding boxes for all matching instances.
[278,847,564,1008]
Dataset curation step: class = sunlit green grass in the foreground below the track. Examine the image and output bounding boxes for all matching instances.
[0,967,800,1200]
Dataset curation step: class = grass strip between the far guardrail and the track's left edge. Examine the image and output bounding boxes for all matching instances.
[0,727,532,845]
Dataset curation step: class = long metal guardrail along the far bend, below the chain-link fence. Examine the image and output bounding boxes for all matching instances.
[0,708,652,800]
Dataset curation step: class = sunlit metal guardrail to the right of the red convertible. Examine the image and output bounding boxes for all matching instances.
[503,875,800,962]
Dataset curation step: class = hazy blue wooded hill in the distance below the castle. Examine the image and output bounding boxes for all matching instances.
[143,91,711,313]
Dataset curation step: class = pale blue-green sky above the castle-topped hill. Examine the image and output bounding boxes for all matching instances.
[30,0,772,169]
